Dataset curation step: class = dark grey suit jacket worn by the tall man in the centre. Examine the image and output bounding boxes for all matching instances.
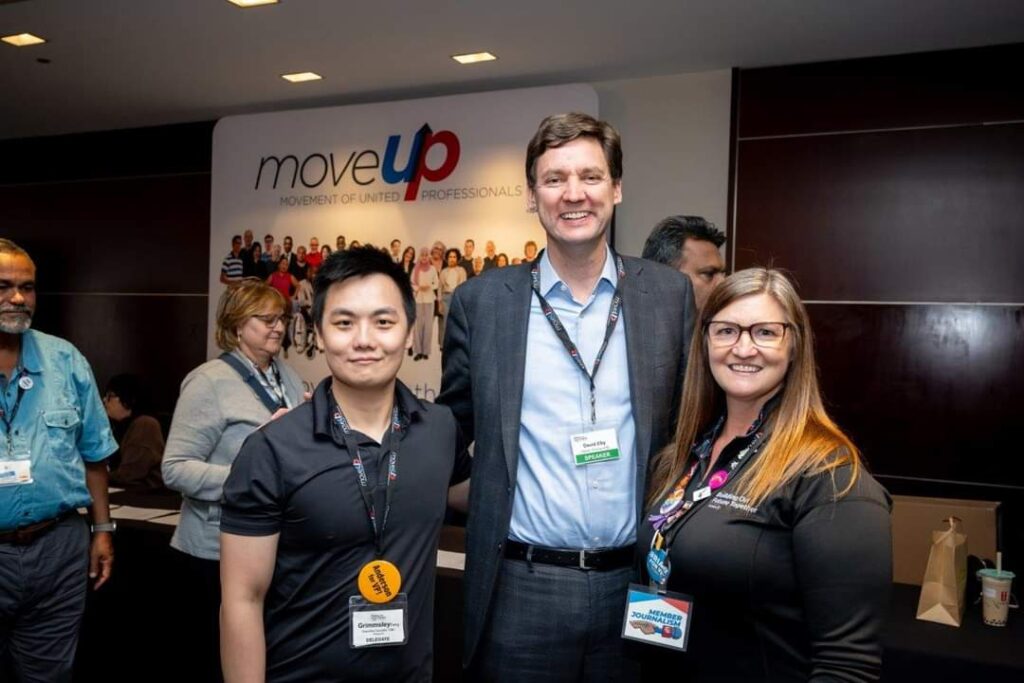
[437,256,695,666]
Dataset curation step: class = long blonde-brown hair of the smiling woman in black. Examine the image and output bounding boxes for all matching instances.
[647,268,861,507]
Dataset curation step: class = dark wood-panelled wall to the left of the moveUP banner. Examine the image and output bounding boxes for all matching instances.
[0,122,214,414]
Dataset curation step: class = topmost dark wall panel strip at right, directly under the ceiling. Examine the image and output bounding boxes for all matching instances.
[738,45,1024,137]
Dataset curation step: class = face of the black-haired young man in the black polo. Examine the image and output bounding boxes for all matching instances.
[316,273,413,389]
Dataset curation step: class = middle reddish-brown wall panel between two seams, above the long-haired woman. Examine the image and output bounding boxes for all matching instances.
[735,124,1024,302]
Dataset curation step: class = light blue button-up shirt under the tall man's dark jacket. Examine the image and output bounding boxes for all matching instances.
[509,249,636,549]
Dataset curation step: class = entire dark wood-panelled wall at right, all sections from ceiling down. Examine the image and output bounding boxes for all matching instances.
[731,45,1024,565]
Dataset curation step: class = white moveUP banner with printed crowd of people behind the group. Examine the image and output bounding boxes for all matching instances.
[208,85,597,400]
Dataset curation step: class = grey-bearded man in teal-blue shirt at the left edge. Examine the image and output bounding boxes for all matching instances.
[0,239,117,681]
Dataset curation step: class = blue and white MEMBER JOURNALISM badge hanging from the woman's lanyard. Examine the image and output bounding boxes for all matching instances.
[623,584,693,652]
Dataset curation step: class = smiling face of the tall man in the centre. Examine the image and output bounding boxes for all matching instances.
[529,137,623,254]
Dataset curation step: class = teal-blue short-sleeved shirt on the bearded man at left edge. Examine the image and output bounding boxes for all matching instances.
[0,330,118,530]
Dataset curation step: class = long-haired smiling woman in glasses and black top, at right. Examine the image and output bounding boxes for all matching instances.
[631,268,892,683]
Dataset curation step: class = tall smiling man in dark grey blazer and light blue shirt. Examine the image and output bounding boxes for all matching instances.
[437,114,694,681]
